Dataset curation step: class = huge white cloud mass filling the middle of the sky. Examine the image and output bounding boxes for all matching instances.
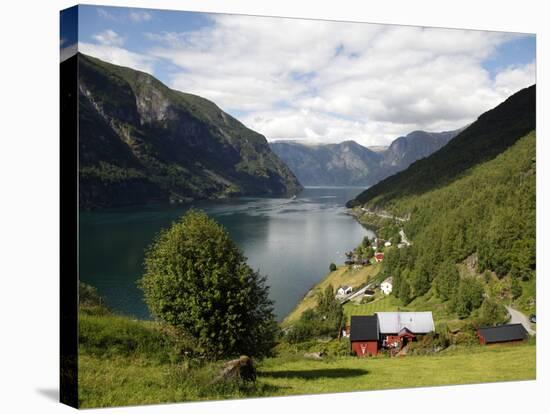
[140,15,534,145]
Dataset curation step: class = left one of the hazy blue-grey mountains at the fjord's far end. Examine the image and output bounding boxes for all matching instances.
[269,141,382,186]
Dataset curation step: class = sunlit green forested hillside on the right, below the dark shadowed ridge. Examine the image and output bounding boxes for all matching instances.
[376,132,536,316]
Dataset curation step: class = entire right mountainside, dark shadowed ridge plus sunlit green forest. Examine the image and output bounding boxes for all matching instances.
[348,86,536,316]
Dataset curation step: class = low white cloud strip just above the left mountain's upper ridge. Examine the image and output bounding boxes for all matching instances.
[78,42,155,75]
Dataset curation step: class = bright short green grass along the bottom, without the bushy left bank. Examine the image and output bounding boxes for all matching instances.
[79,344,536,407]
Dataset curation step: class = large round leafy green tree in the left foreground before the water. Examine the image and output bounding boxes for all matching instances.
[139,210,277,358]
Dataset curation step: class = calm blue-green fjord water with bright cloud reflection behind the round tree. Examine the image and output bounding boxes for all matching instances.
[80,187,373,319]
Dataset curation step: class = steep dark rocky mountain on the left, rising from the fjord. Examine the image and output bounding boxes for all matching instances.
[73,54,302,208]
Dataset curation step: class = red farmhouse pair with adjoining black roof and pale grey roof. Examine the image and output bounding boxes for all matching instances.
[349,312,435,357]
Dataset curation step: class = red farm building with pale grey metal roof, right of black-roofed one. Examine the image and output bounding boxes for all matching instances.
[376,312,435,348]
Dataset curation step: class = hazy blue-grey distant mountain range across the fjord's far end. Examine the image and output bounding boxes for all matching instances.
[269,129,461,187]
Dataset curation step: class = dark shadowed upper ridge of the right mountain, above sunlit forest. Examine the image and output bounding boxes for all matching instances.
[348,85,536,207]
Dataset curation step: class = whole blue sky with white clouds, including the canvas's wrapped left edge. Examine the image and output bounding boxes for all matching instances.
[60,6,536,146]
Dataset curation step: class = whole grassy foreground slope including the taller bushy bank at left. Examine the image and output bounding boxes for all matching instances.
[78,315,536,408]
